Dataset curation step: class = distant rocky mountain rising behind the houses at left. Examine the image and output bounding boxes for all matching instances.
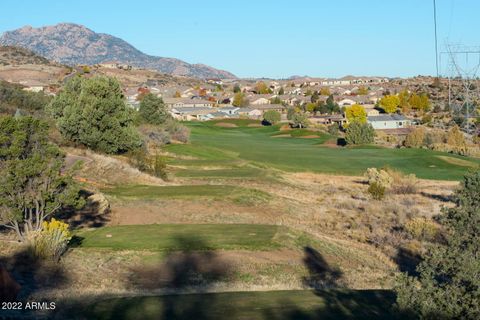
[0,23,236,79]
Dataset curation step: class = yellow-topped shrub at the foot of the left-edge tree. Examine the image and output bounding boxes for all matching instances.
[31,218,72,260]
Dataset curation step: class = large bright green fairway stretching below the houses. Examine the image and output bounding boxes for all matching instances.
[166,121,480,180]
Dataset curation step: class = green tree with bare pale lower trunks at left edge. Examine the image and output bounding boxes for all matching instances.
[0,116,82,241]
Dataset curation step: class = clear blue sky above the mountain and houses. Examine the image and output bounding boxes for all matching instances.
[0,0,480,78]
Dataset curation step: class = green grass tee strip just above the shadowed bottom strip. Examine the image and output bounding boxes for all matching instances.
[76,224,284,251]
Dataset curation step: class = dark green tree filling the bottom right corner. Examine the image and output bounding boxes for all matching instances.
[396,171,480,320]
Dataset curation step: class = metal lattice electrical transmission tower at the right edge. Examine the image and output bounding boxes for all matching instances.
[440,45,480,134]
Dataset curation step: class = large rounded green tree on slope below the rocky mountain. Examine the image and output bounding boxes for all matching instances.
[47,77,142,153]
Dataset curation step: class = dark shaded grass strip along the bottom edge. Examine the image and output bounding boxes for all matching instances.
[80,290,406,320]
